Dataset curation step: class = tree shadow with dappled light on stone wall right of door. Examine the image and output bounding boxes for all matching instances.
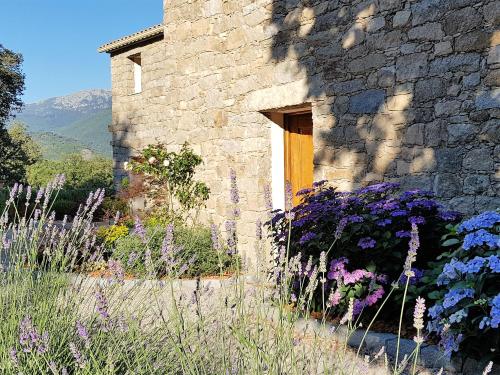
[271,0,500,211]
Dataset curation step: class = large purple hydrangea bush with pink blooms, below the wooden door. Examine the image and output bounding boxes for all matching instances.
[267,181,459,315]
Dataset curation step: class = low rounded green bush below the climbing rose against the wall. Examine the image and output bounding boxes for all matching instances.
[111,223,236,277]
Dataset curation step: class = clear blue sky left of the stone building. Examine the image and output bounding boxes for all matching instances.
[0,0,163,103]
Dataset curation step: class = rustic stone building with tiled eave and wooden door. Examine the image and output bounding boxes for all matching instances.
[99,0,500,266]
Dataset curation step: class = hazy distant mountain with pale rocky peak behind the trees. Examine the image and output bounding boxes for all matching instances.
[16,89,112,159]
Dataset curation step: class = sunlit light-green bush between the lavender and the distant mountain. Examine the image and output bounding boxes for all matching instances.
[27,154,113,218]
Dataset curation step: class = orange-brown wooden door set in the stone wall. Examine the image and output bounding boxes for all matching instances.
[285,113,314,205]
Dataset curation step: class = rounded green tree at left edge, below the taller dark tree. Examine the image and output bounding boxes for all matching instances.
[0,122,42,184]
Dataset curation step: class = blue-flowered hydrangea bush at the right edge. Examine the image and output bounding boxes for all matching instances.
[424,211,500,363]
